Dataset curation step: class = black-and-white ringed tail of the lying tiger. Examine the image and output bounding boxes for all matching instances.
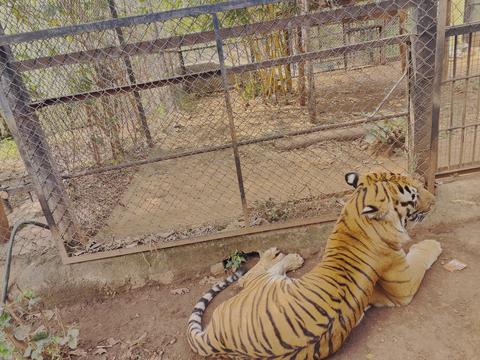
[187,268,247,355]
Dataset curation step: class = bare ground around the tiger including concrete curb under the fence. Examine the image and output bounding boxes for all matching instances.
[0,174,480,360]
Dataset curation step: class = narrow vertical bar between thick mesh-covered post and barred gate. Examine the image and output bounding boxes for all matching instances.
[427,0,448,192]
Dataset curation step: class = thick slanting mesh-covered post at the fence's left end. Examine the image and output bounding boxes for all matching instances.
[0,26,84,259]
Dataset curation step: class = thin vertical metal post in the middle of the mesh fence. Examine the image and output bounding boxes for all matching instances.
[212,13,248,226]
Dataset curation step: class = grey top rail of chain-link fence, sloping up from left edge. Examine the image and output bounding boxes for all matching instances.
[0,0,286,45]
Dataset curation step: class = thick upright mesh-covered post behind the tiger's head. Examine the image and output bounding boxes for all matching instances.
[410,0,437,189]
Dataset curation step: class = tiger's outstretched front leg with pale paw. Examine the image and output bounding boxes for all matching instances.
[370,240,442,306]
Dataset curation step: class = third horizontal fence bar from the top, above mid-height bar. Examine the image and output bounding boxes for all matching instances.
[31,35,410,109]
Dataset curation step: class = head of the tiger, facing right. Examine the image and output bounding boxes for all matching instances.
[345,172,435,246]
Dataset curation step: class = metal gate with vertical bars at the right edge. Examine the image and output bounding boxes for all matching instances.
[437,1,480,177]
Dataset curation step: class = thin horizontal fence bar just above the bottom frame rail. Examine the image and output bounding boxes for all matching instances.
[62,111,409,179]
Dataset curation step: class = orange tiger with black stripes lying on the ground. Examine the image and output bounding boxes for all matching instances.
[187,172,442,359]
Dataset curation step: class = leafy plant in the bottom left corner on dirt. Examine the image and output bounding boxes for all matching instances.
[0,290,79,360]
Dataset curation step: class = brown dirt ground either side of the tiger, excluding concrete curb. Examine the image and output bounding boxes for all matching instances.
[36,175,480,360]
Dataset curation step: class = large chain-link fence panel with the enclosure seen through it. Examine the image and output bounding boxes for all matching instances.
[0,0,478,262]
